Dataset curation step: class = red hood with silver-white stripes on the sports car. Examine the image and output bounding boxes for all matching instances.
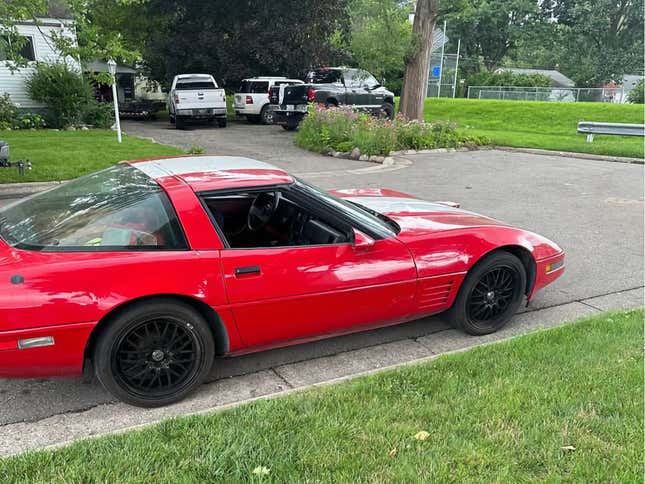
[333,189,507,239]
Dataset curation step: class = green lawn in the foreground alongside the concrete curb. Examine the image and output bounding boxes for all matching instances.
[0,310,644,483]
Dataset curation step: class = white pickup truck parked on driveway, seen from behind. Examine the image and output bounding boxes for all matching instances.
[168,74,226,129]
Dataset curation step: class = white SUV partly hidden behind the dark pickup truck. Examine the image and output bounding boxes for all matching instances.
[233,77,303,124]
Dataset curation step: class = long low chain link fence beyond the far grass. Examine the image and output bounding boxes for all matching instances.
[467,86,629,103]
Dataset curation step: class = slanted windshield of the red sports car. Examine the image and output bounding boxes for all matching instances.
[296,179,400,239]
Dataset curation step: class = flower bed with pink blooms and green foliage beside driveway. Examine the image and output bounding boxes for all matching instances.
[296,106,488,156]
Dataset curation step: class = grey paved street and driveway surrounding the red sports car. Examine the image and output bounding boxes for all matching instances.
[0,119,644,455]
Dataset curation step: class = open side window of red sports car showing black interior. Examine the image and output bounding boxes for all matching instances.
[204,191,352,248]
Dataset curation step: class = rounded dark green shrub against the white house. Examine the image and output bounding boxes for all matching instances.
[27,64,92,128]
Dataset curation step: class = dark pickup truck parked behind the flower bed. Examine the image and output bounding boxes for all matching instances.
[269,67,394,131]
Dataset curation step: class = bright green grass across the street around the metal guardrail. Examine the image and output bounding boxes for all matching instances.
[425,99,645,158]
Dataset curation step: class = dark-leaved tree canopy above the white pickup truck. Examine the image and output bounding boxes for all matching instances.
[120,0,347,88]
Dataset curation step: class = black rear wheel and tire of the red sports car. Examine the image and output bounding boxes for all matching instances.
[92,299,215,407]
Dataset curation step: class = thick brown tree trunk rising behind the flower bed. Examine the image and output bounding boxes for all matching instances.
[399,0,440,121]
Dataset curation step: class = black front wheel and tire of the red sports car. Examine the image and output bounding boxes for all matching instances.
[446,251,526,336]
